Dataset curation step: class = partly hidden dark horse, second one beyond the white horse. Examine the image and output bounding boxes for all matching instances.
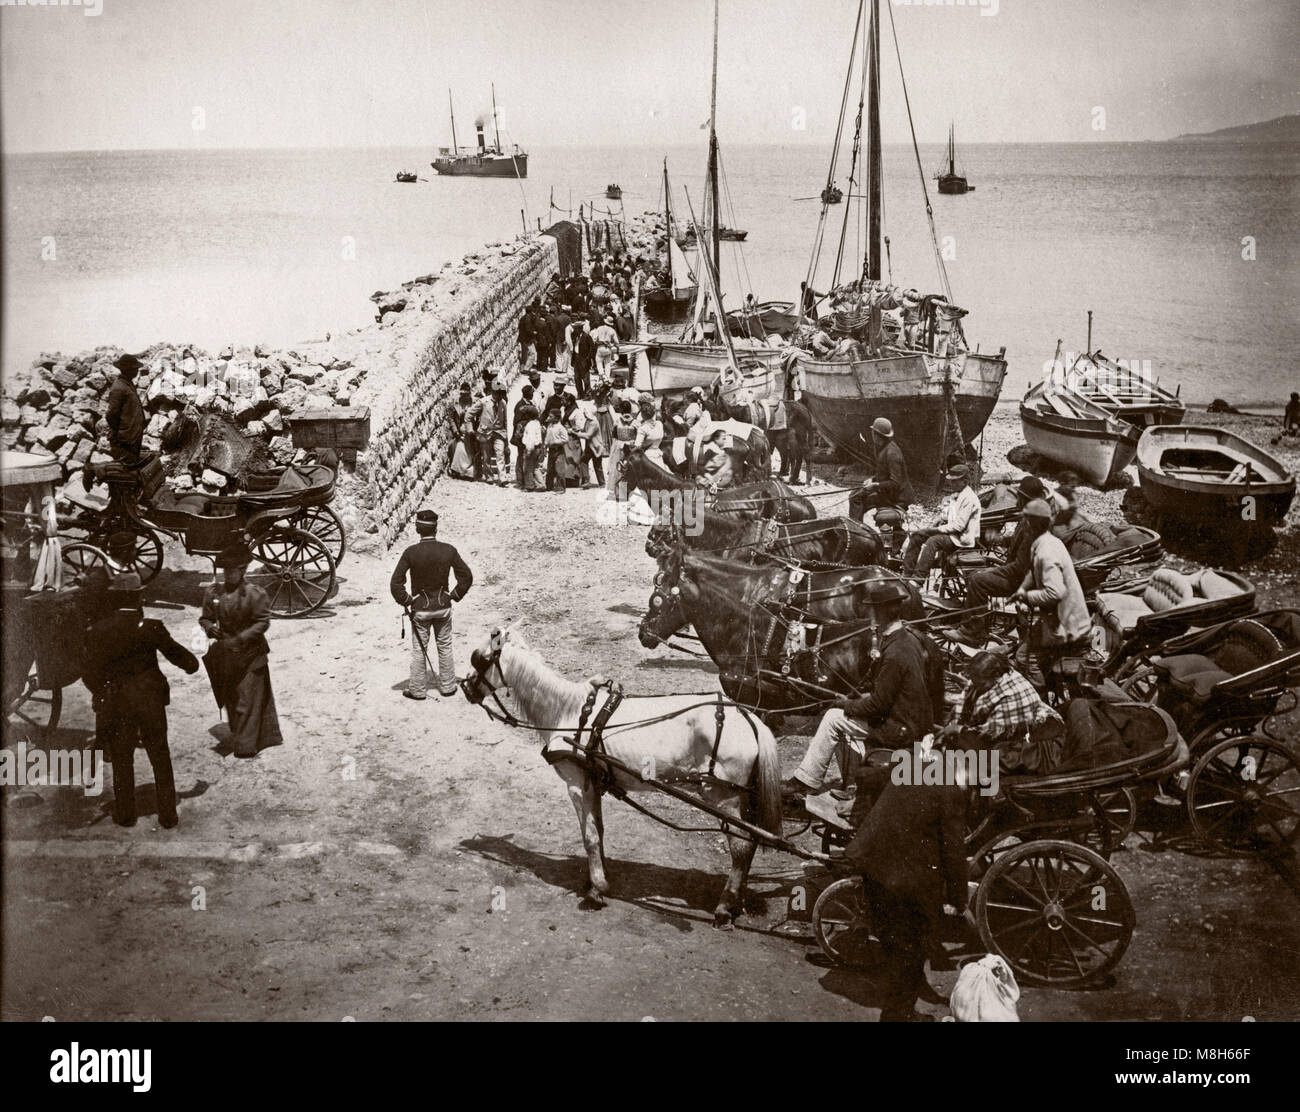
[646,510,884,568]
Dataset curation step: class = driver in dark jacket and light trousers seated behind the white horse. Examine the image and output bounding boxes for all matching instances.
[781,601,944,808]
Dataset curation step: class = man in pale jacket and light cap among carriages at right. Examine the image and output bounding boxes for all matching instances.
[1011,498,1092,684]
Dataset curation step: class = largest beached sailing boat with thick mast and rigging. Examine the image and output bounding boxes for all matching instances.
[789,0,1006,488]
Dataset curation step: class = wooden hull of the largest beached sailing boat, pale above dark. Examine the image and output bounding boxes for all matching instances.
[800,352,1006,485]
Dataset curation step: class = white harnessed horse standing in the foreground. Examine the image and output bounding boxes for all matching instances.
[464,629,781,930]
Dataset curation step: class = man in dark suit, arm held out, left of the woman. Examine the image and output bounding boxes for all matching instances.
[82,574,199,830]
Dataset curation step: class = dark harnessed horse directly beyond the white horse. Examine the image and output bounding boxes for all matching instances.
[638,548,926,711]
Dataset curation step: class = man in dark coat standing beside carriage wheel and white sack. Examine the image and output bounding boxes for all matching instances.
[836,769,967,1022]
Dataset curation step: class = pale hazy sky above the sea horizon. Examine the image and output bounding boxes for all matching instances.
[0,0,1300,152]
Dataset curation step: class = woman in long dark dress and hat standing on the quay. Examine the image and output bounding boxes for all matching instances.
[199,542,285,757]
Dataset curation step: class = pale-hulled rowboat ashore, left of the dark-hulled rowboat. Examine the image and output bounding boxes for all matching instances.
[1021,381,1140,486]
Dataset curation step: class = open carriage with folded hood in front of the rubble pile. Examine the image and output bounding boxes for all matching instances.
[61,457,345,618]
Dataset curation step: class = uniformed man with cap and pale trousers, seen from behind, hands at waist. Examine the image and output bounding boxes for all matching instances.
[389,510,475,700]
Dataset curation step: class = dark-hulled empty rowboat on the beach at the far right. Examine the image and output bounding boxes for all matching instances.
[1138,425,1296,528]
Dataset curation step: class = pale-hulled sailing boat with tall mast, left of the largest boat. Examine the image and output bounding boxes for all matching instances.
[637,0,785,399]
